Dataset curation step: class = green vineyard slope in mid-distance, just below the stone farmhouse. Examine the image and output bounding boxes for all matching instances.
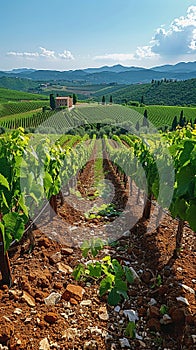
[0,101,196,133]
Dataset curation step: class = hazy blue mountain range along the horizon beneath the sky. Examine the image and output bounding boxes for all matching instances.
[0,61,196,84]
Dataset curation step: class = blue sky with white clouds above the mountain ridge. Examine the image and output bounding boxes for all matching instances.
[0,0,196,71]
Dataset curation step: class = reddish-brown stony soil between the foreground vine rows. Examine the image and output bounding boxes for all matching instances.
[0,154,196,350]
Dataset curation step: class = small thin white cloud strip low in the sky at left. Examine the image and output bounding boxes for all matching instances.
[7,46,74,60]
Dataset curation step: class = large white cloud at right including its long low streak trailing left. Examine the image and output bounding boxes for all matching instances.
[94,6,196,62]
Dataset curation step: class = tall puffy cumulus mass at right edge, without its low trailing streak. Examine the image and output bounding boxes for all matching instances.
[151,6,196,57]
